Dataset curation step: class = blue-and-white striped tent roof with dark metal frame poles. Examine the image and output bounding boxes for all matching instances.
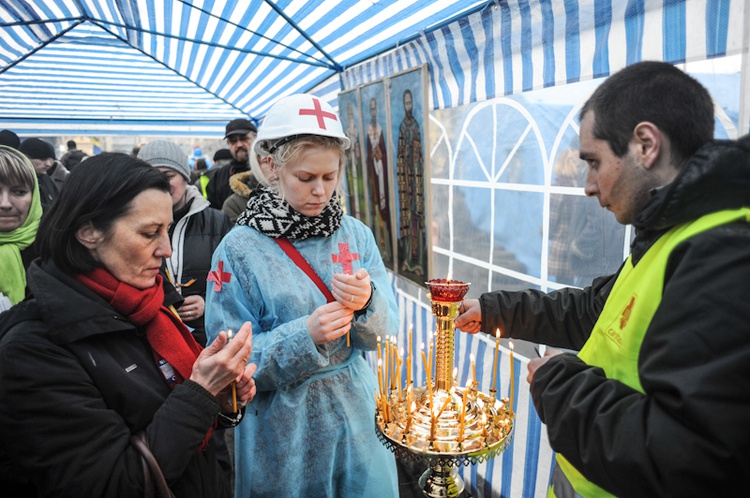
[0,0,492,136]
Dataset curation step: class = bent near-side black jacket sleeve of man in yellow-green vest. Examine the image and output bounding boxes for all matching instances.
[531,224,750,497]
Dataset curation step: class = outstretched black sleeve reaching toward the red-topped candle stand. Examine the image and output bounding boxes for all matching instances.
[479,271,619,350]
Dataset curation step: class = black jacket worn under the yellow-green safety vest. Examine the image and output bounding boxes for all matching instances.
[480,137,750,497]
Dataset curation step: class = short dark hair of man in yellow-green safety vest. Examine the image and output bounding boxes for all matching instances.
[580,61,714,167]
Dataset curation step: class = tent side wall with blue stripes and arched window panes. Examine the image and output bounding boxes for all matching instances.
[342,0,750,498]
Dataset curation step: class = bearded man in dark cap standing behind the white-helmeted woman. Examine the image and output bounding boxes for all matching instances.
[206,119,258,210]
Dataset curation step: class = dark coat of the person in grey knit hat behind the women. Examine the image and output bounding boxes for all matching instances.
[165,185,232,346]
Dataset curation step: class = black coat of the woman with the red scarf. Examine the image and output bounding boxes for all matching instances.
[0,261,230,498]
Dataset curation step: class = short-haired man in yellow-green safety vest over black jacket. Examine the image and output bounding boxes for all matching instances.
[456,62,750,497]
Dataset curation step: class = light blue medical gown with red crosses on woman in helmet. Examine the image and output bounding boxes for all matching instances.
[206,216,398,498]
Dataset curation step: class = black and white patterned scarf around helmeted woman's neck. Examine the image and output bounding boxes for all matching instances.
[237,187,344,240]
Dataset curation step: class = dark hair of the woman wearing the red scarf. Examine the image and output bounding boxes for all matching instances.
[36,152,170,274]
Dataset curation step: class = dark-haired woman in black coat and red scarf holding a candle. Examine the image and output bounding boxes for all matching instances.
[0,154,255,498]
